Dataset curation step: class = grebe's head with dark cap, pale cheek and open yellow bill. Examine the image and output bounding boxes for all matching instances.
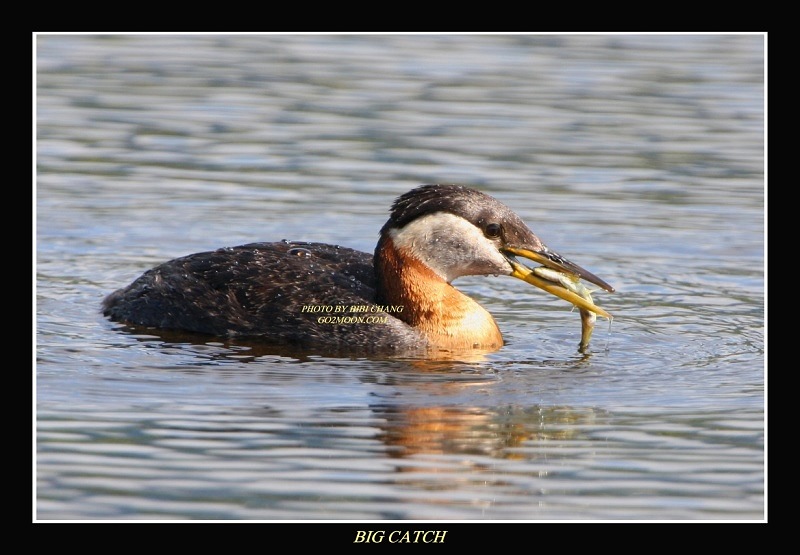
[376,185,614,316]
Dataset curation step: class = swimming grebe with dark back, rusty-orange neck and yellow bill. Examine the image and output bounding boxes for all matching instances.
[103,185,614,352]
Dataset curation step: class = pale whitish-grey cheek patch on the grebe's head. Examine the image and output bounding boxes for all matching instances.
[389,212,511,283]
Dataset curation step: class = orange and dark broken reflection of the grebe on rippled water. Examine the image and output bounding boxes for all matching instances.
[111,328,596,464]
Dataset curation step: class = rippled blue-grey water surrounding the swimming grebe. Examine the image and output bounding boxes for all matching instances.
[34,35,766,522]
